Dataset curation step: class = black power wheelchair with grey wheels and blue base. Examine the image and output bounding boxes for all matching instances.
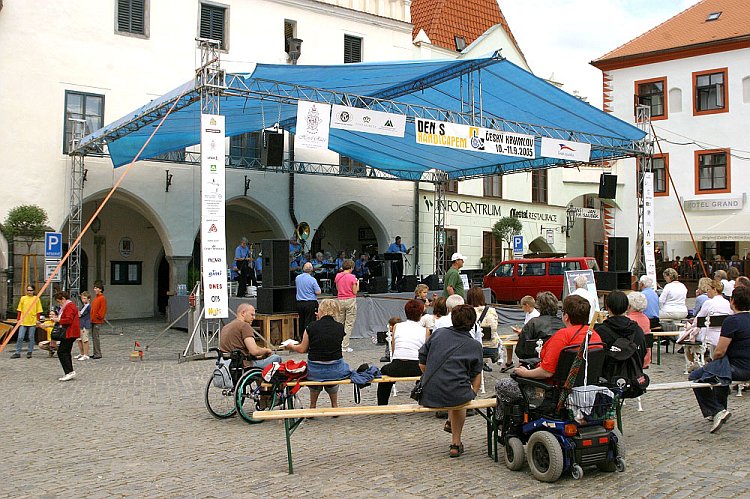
[499,343,625,482]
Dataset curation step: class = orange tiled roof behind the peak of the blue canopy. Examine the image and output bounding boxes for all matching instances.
[411,0,523,57]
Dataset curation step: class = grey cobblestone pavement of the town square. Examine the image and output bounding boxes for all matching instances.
[0,321,750,498]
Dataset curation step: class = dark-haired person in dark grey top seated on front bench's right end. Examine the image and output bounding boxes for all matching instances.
[419,305,482,457]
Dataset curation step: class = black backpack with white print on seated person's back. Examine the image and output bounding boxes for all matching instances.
[602,337,649,398]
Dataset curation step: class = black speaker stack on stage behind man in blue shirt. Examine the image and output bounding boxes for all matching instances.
[257,239,297,314]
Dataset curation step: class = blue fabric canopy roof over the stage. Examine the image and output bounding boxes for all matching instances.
[76,55,645,180]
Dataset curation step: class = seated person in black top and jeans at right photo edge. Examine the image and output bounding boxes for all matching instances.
[690,287,750,433]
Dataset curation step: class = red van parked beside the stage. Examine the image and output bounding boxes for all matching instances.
[484,257,599,303]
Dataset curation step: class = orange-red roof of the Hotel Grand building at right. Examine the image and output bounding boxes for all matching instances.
[592,0,750,68]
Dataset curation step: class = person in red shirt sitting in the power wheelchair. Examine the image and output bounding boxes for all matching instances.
[495,295,601,421]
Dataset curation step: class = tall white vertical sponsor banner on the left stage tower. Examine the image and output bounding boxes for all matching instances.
[201,114,229,319]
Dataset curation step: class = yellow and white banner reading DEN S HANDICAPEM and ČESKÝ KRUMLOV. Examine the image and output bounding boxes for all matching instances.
[414,118,536,159]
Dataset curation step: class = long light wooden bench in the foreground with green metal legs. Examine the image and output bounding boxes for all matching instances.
[253,398,498,474]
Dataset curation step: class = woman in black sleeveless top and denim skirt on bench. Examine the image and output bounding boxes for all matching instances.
[284,299,352,409]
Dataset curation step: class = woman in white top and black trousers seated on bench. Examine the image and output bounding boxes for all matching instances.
[378,300,429,405]
